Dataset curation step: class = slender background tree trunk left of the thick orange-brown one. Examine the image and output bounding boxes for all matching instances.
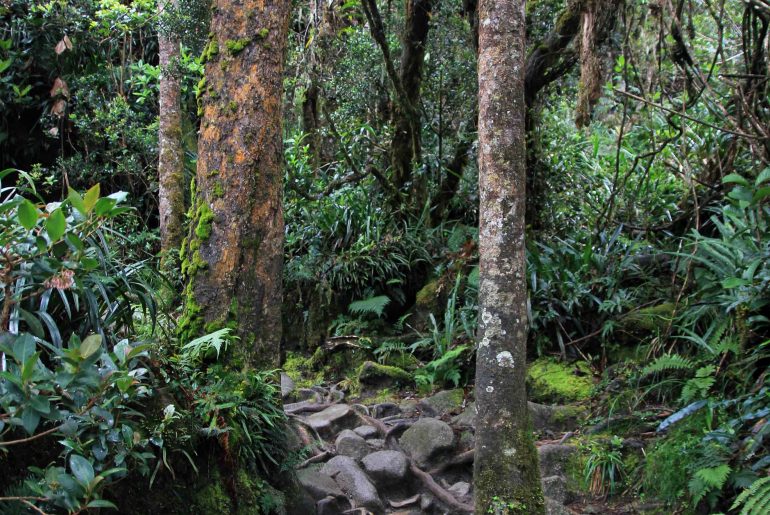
[158,0,185,256]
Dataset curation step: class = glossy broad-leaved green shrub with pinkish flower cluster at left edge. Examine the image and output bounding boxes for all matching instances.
[0,176,154,511]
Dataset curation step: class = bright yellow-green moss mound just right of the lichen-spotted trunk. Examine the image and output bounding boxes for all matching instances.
[527,358,593,403]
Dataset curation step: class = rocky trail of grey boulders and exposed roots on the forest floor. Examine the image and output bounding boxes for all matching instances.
[281,370,596,515]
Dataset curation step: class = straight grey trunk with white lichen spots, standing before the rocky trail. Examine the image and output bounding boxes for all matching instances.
[473,0,544,514]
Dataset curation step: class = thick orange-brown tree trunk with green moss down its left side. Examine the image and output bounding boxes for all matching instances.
[179,0,291,368]
